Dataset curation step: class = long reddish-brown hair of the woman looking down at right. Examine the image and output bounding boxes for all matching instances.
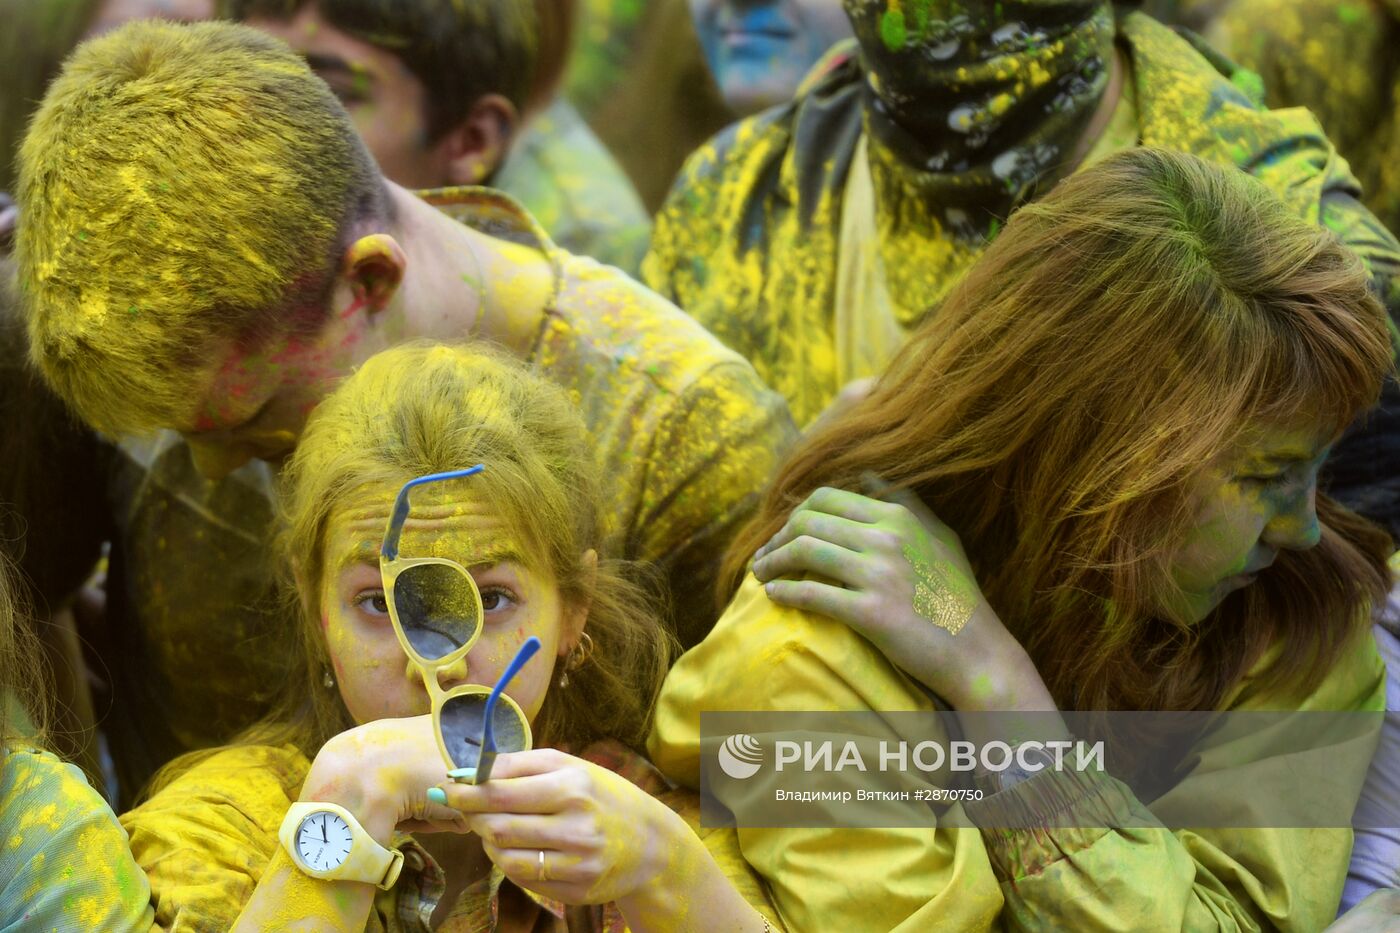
[728,148,1390,710]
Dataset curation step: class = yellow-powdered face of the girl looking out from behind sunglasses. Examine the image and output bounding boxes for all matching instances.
[319,481,587,724]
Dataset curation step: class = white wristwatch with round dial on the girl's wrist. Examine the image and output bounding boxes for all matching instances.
[277,801,403,891]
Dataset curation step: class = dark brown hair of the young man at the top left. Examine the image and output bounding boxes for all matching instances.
[221,0,540,141]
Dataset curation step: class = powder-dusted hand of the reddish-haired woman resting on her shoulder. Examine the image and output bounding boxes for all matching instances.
[753,488,1049,710]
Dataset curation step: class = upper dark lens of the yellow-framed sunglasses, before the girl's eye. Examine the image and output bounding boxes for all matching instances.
[393,554,482,661]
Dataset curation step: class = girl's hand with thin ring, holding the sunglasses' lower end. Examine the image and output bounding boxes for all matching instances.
[440,748,697,902]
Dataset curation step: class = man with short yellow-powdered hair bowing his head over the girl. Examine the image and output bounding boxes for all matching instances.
[17,22,792,794]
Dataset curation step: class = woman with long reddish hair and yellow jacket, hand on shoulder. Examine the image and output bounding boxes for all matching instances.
[650,148,1390,933]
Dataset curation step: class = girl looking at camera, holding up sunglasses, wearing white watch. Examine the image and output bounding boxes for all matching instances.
[123,346,770,933]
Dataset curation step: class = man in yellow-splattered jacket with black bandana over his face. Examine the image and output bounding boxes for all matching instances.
[643,0,1400,537]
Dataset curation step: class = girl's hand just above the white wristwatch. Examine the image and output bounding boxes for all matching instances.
[301,716,468,846]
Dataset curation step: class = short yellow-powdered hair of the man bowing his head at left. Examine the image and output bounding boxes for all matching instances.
[17,21,389,434]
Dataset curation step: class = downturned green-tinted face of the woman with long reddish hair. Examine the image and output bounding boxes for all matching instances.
[1162,429,1330,622]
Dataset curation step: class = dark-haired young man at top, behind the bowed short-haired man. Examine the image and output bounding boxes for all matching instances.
[223,0,651,275]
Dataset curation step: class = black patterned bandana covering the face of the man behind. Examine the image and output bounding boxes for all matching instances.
[846,0,1114,237]
